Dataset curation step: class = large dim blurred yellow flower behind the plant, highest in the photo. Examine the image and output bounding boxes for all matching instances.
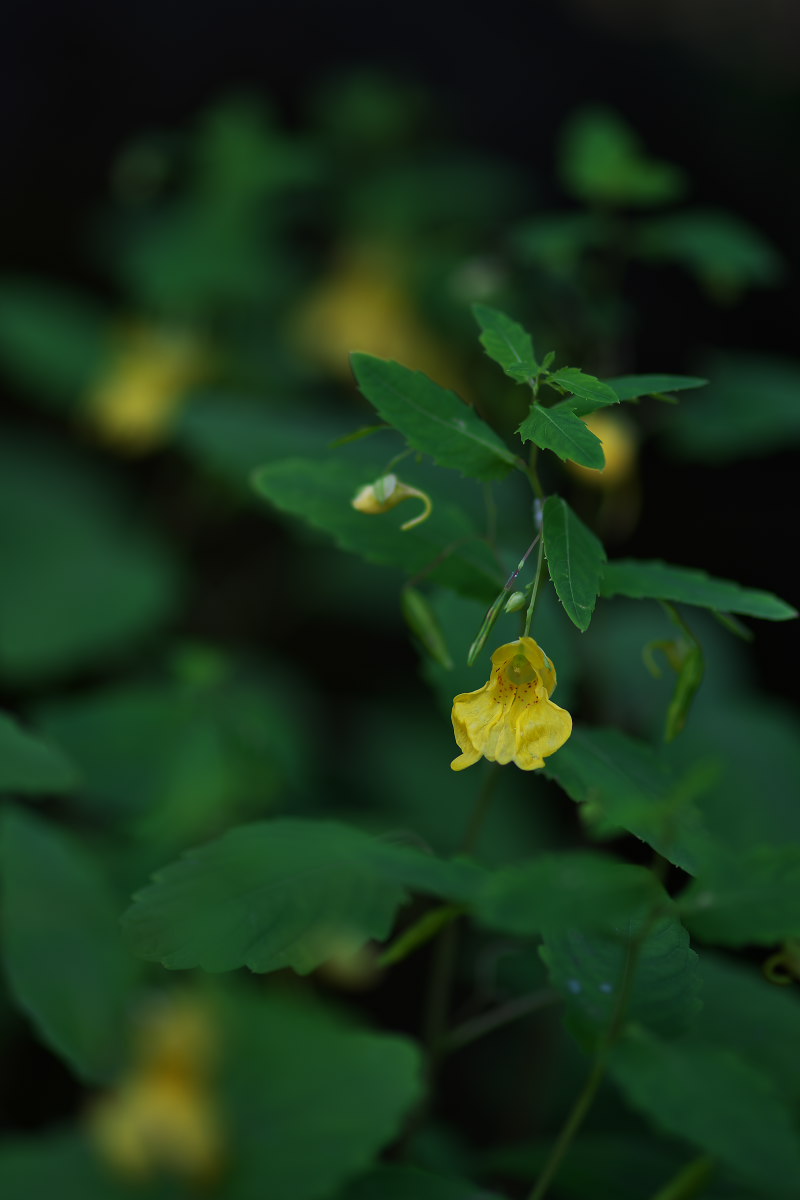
[294,245,463,395]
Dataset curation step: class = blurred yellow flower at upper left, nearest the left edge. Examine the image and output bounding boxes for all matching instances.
[86,325,209,454]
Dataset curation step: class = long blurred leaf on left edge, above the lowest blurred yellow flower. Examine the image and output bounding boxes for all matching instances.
[0,809,136,1080]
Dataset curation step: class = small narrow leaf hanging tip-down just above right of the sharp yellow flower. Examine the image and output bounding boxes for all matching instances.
[542,496,606,632]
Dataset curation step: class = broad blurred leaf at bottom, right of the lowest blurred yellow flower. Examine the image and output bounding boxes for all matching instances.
[219,989,423,1200]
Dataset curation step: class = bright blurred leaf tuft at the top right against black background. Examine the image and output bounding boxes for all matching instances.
[559,107,686,208]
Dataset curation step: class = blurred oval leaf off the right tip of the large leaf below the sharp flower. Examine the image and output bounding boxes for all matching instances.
[471,851,660,937]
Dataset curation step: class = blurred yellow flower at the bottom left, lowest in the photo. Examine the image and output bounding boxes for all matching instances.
[89,997,223,1183]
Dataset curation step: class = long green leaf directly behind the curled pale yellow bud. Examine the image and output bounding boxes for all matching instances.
[253,458,504,602]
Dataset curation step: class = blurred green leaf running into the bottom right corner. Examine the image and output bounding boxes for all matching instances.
[610,1030,800,1200]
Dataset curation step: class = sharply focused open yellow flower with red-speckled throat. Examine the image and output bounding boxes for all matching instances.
[450,637,572,770]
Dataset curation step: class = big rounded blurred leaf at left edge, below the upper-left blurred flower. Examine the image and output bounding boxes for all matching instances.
[0,437,179,682]
